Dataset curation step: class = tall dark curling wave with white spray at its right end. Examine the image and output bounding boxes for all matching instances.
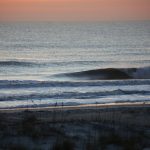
[55,67,150,80]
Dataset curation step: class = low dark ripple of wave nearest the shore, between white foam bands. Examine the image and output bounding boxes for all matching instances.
[0,89,150,101]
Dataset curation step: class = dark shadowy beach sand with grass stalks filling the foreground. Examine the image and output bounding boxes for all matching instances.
[0,103,150,150]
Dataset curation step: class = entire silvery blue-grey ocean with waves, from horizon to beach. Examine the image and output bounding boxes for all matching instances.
[0,21,150,108]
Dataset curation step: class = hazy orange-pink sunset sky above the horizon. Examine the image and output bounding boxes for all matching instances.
[0,0,150,21]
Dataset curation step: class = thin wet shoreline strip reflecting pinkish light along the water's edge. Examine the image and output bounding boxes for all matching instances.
[0,101,150,112]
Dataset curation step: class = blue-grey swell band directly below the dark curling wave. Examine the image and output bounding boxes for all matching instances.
[0,79,150,89]
